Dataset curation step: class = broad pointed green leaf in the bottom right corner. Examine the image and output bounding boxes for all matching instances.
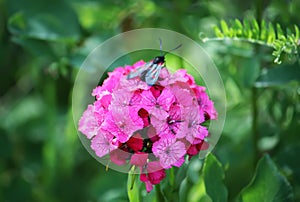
[240,155,293,202]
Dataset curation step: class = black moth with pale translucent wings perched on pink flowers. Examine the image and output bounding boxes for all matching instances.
[127,39,182,86]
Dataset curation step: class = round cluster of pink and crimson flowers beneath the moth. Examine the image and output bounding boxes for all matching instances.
[79,61,217,192]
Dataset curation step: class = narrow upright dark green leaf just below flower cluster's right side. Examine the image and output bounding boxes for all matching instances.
[203,154,228,202]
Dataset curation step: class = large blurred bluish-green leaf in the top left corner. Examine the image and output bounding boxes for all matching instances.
[8,0,80,42]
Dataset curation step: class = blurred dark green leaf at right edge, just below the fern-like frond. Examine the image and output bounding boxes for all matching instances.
[255,64,300,88]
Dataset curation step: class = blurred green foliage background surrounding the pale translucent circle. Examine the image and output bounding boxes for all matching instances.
[0,0,300,202]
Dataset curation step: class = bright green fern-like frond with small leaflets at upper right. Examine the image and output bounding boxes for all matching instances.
[202,19,300,64]
